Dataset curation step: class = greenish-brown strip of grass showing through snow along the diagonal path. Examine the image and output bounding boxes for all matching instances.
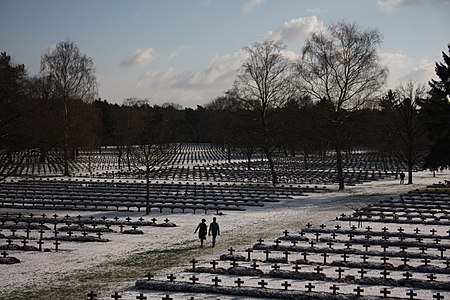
[0,199,348,300]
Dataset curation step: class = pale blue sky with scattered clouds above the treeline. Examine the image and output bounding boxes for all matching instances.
[0,0,450,108]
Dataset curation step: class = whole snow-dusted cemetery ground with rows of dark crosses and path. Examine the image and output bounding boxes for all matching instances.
[0,145,450,300]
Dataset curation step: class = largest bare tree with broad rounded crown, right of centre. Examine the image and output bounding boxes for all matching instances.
[295,22,388,190]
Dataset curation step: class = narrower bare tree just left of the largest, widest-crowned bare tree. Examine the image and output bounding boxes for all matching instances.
[234,40,290,184]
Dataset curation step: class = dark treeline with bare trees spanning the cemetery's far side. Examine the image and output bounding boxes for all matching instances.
[0,29,450,188]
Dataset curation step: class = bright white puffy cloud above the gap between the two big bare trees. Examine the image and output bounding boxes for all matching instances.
[267,16,324,44]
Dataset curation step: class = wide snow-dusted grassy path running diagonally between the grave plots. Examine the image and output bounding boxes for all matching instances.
[0,172,449,300]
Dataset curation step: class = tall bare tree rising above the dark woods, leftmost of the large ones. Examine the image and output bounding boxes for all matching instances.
[41,40,97,176]
